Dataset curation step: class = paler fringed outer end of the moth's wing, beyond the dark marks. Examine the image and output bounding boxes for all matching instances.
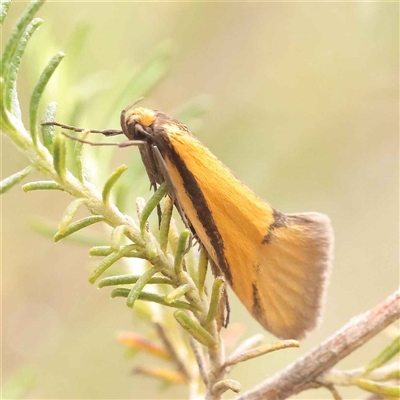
[251,212,333,339]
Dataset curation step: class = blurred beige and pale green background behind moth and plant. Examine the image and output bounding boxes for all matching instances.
[1,1,399,399]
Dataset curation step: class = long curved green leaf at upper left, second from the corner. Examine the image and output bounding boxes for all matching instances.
[4,18,43,115]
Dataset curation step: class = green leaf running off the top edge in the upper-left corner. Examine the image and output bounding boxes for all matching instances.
[0,0,45,76]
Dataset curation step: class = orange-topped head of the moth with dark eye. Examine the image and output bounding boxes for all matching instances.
[121,107,156,140]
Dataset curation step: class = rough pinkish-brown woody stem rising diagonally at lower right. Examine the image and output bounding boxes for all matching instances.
[236,289,400,400]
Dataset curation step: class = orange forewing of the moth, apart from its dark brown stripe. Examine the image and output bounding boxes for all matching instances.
[161,126,333,338]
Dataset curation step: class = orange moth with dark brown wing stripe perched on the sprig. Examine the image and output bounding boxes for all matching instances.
[52,101,333,339]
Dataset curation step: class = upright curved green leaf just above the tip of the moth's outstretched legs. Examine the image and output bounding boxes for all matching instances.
[29,52,65,145]
